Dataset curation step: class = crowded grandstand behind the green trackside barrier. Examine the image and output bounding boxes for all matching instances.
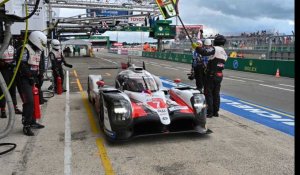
[164,31,295,60]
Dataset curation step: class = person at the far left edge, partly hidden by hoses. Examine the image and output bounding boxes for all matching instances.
[0,39,22,118]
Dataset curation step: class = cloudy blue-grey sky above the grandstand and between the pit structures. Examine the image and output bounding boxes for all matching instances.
[60,0,295,42]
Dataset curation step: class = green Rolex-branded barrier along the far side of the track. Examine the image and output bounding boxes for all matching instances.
[142,52,295,78]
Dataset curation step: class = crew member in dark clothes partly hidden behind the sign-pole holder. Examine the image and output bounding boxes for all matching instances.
[189,40,205,93]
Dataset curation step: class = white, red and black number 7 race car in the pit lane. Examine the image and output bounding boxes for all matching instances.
[87,63,212,141]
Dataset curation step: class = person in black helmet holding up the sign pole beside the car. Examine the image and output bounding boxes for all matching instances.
[205,35,228,118]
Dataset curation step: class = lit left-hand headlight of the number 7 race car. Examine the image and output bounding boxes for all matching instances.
[112,100,131,123]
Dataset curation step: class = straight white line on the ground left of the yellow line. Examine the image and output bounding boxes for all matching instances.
[64,71,72,175]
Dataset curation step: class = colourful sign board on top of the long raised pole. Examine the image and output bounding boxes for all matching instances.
[156,0,178,19]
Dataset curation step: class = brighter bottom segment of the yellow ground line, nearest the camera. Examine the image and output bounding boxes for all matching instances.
[96,138,115,175]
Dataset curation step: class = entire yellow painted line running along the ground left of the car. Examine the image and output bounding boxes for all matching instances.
[74,70,115,175]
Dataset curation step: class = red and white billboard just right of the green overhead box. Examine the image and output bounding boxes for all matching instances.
[175,25,203,42]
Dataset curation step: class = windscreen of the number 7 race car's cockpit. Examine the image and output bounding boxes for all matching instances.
[126,77,158,92]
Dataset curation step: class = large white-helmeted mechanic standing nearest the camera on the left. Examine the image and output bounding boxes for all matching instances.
[17,31,47,136]
